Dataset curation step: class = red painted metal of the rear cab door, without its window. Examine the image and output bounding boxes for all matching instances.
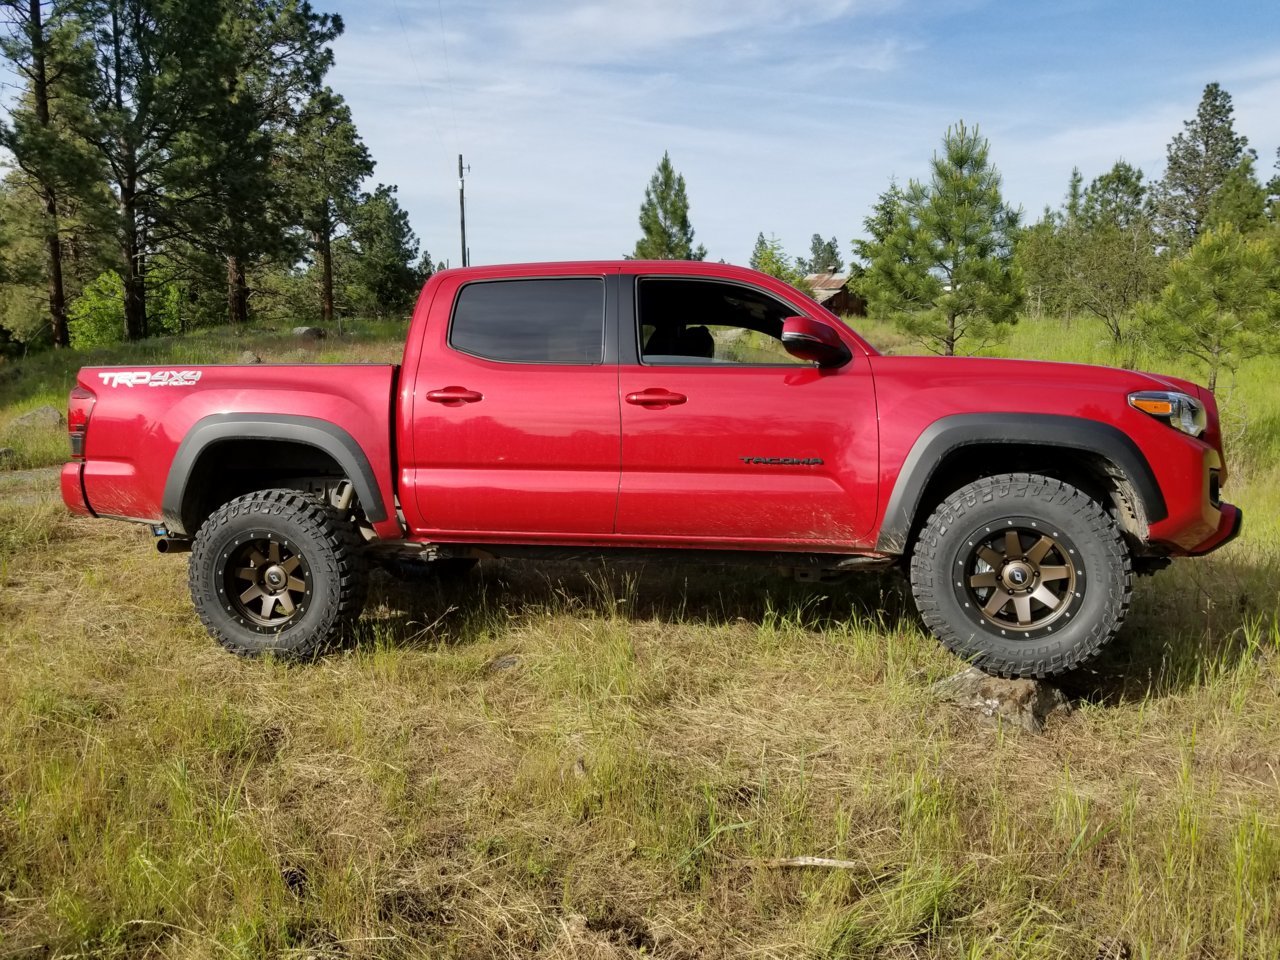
[398,266,620,540]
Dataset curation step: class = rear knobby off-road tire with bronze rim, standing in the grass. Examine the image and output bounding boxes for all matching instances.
[188,490,367,659]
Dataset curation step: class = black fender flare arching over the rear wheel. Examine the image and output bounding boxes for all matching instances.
[160,413,387,535]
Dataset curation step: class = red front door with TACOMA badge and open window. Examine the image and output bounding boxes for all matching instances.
[617,276,878,550]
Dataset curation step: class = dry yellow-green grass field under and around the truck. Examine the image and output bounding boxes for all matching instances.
[0,313,1280,960]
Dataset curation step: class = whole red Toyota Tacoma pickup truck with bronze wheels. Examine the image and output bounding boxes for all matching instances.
[61,261,1240,676]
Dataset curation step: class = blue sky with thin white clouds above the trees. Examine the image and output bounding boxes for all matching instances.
[316,0,1280,265]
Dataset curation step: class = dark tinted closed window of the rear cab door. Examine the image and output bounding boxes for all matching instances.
[449,276,604,364]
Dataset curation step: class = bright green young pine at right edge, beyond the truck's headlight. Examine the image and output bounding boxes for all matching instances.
[1143,224,1280,390]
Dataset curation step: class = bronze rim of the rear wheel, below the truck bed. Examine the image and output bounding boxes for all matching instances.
[223,535,311,632]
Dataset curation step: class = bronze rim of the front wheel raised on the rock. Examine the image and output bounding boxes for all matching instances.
[956,521,1083,635]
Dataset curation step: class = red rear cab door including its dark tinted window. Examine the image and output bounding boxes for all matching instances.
[402,275,620,541]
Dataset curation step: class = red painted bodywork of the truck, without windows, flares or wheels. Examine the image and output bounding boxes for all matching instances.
[63,261,1238,563]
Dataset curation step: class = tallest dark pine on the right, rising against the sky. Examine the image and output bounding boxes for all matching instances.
[1156,83,1249,248]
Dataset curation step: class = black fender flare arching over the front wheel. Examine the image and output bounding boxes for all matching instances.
[876,413,1169,554]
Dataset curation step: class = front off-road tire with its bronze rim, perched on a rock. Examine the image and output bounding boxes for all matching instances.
[910,474,1132,677]
